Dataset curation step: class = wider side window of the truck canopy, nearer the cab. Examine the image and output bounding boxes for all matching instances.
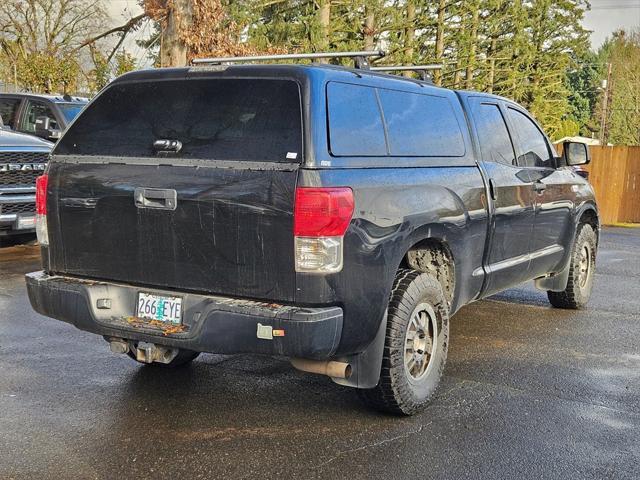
[379,90,465,157]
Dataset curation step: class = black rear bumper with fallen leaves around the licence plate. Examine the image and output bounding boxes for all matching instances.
[26,272,343,359]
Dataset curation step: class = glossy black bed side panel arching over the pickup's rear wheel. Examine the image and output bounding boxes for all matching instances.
[295,167,488,357]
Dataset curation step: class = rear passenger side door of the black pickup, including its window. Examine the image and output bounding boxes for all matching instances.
[469,97,535,296]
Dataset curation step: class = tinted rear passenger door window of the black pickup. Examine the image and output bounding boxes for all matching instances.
[473,102,516,165]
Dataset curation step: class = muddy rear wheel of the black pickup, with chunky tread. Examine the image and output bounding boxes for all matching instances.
[358,269,449,415]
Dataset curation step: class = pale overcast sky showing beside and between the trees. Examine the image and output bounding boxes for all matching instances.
[106,0,640,66]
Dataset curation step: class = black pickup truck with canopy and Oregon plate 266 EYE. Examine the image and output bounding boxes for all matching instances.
[26,60,599,414]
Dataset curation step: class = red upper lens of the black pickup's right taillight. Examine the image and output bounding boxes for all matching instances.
[293,187,353,237]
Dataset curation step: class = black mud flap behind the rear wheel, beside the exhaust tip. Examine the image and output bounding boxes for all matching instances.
[332,310,387,388]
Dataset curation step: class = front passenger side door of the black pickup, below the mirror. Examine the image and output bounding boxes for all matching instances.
[507,105,575,278]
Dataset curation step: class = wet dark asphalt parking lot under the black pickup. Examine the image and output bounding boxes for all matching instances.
[0,229,640,479]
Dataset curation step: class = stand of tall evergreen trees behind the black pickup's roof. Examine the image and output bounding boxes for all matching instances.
[136,0,597,138]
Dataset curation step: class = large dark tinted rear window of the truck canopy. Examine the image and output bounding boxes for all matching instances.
[54,79,302,162]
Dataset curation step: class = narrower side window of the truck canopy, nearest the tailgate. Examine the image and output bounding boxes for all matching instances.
[327,82,387,156]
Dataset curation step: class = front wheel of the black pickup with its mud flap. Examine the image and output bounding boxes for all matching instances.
[547,223,597,309]
